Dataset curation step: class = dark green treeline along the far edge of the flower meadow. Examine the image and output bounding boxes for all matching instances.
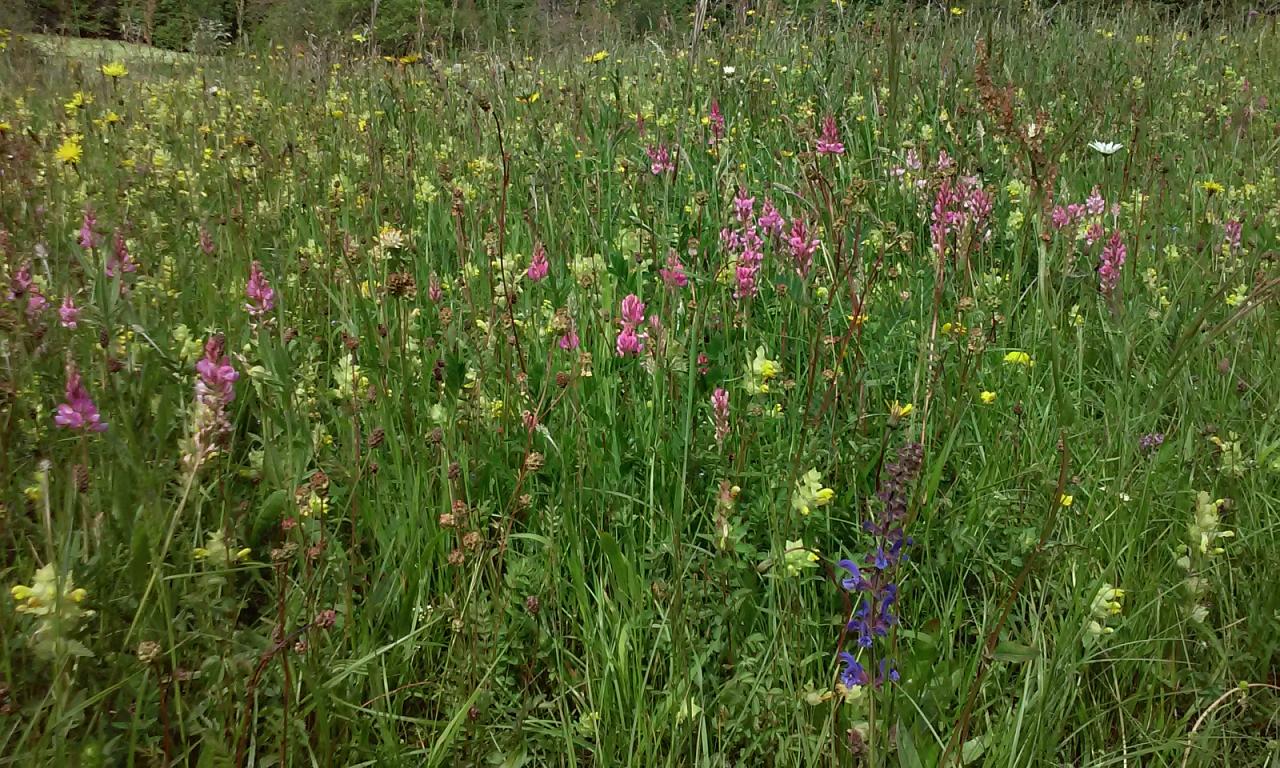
[0,0,1280,54]
